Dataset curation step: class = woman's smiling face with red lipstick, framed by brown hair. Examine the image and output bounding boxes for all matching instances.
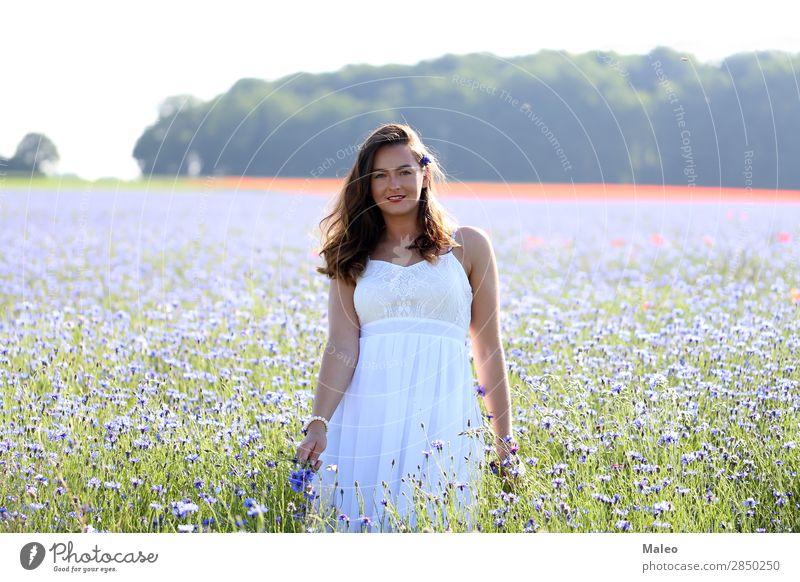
[370,144,428,215]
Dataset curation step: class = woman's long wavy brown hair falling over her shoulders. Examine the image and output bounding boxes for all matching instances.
[317,123,461,284]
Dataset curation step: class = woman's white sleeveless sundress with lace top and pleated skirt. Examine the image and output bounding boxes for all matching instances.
[315,250,484,532]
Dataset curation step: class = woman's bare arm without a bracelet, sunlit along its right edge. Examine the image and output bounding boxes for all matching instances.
[459,226,512,461]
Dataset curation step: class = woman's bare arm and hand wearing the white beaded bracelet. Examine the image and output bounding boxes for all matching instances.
[297,279,361,470]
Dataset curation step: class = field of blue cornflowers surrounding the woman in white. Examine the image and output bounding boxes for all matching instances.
[0,188,800,533]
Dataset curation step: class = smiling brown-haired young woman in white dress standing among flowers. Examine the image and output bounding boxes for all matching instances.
[297,124,512,531]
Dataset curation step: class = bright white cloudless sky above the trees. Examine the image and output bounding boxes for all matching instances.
[0,0,800,179]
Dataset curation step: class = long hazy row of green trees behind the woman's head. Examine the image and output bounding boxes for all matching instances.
[133,48,800,188]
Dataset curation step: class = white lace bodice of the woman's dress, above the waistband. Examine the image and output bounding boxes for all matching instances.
[353,250,472,330]
